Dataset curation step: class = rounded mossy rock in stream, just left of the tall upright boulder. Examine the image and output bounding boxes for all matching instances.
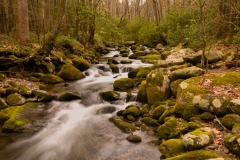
[113,78,134,90]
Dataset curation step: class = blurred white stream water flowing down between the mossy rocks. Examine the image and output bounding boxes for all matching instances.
[0,51,160,160]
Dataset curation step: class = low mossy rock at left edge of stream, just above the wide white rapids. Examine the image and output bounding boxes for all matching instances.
[58,91,82,101]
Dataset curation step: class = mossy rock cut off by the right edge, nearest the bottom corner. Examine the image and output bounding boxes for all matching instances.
[224,134,240,156]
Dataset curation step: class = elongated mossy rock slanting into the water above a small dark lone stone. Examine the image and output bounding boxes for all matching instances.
[109,117,136,133]
